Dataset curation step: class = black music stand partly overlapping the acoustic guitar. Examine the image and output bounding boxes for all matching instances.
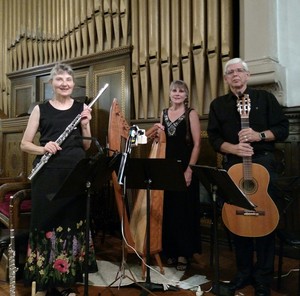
[190,165,256,295]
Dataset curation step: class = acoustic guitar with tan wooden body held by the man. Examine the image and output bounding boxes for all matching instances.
[222,94,279,237]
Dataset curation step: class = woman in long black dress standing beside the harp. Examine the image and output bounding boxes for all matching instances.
[158,80,201,270]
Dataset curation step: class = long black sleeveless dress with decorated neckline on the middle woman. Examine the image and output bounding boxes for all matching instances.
[162,109,200,259]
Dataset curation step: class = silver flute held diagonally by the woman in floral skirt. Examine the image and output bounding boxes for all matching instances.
[28,83,109,180]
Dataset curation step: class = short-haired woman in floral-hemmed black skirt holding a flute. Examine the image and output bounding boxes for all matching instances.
[21,64,97,296]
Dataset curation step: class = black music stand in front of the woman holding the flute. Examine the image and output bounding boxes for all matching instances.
[54,153,119,296]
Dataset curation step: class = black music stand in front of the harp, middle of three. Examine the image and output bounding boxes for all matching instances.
[125,158,186,295]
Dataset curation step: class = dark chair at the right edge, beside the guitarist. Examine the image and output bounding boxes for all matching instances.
[275,176,300,295]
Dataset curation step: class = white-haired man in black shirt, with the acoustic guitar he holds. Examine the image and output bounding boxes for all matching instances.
[207,58,289,296]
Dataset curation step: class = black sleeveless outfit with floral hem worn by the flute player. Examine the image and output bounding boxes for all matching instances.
[24,101,97,290]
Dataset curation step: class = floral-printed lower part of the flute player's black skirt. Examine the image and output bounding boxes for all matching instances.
[24,220,97,291]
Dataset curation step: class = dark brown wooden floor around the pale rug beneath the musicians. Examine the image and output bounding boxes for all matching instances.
[0,231,299,296]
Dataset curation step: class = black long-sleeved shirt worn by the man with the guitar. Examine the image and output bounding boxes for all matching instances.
[207,88,289,154]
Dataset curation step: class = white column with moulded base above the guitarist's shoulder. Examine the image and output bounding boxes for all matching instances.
[240,0,286,105]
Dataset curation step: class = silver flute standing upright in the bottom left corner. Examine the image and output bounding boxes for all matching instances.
[8,195,18,296]
